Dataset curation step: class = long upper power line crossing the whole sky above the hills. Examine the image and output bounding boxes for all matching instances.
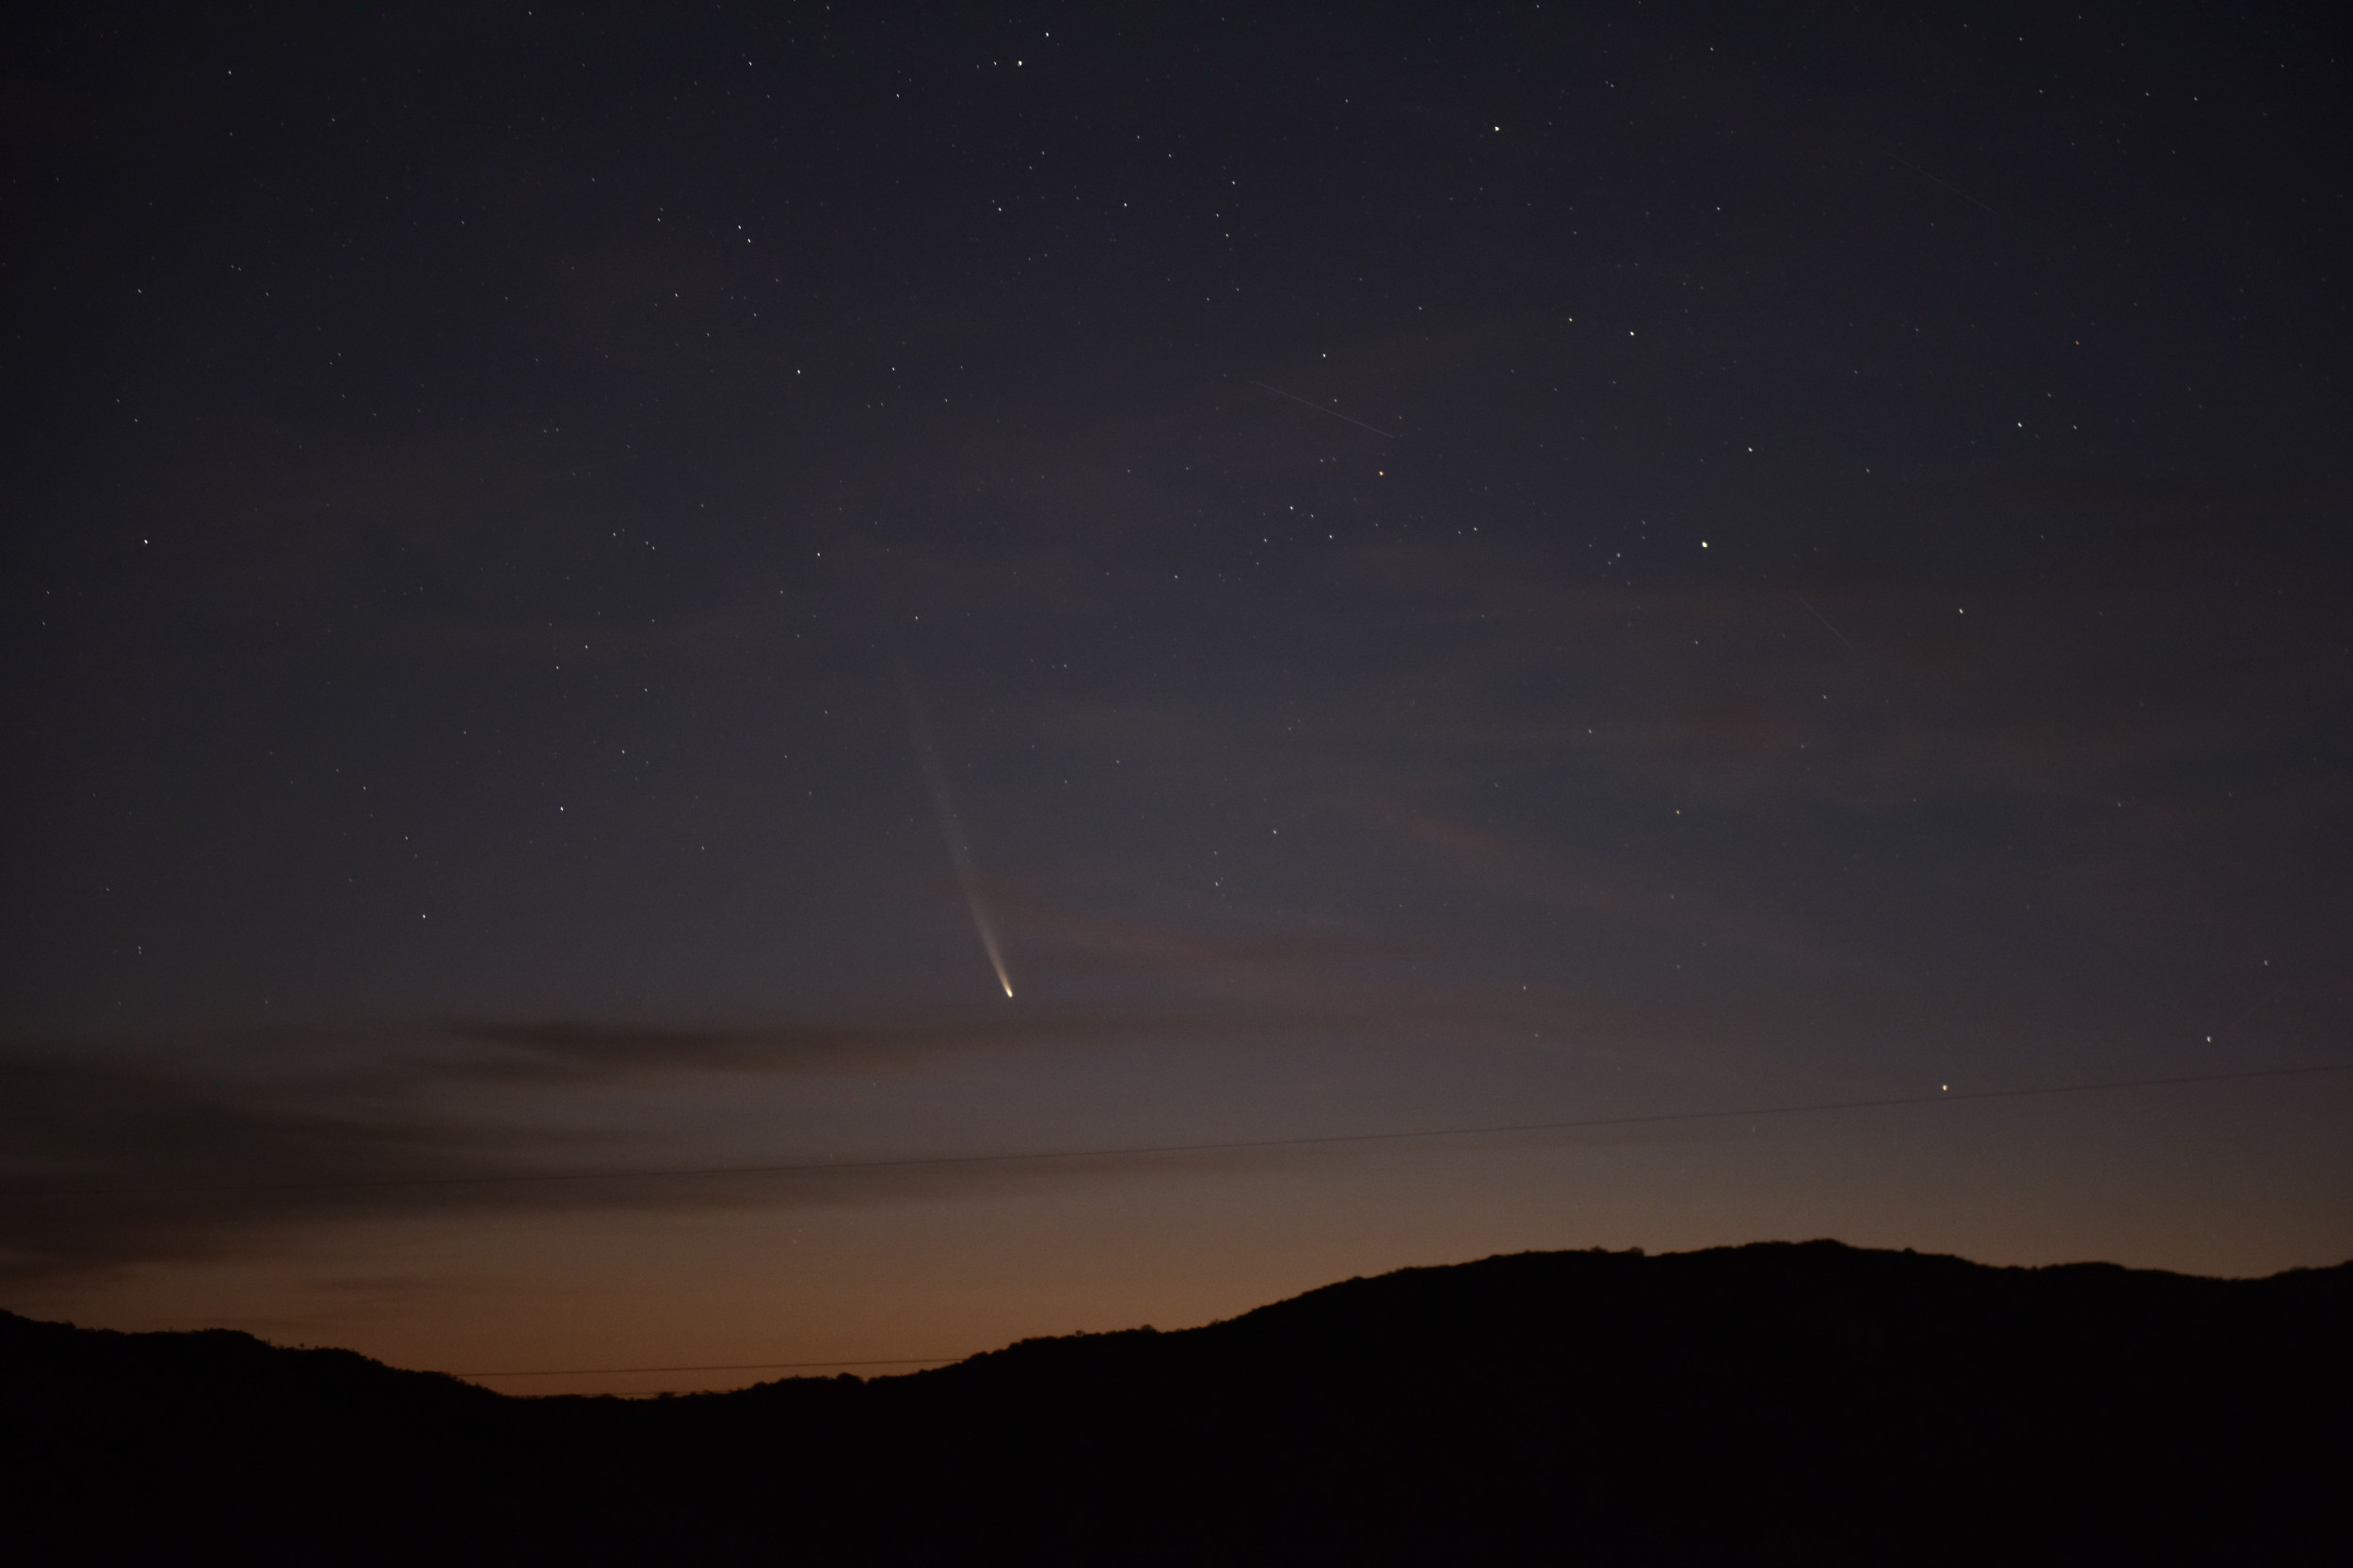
[0,1062,2353,1198]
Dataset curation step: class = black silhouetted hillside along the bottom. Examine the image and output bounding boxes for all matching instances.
[0,1243,2353,1565]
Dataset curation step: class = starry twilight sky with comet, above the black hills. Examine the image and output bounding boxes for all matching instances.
[0,0,2353,1391]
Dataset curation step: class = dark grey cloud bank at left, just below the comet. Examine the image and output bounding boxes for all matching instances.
[0,994,1544,1276]
